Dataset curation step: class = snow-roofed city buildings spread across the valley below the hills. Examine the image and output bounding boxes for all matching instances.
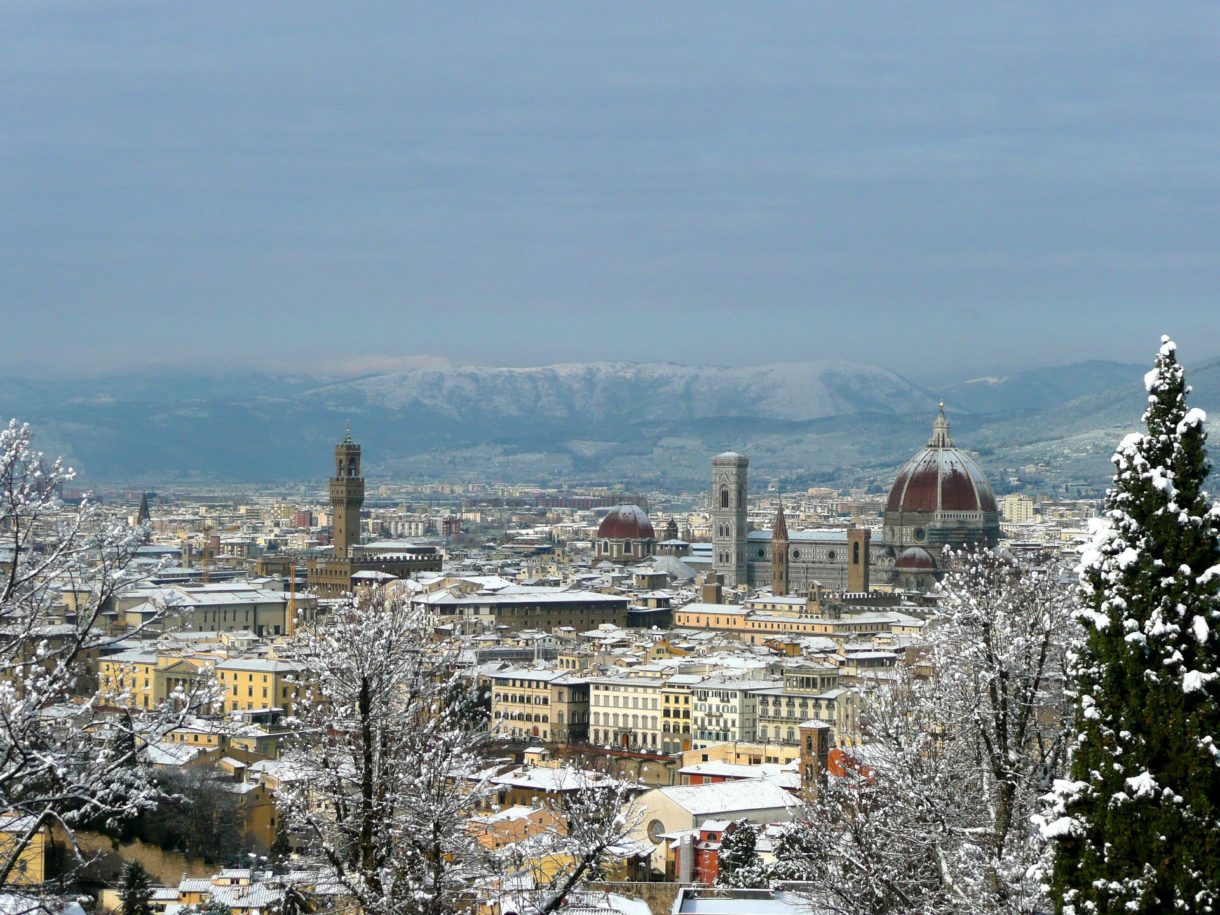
[0,407,1093,915]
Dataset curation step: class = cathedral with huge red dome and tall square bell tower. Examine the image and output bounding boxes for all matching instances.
[711,404,1000,594]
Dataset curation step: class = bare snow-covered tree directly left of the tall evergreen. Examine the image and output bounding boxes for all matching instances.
[773,550,1071,915]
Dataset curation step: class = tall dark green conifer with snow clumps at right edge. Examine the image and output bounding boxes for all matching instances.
[1043,338,1220,915]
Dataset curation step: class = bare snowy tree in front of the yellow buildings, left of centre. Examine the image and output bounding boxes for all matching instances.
[277,586,486,915]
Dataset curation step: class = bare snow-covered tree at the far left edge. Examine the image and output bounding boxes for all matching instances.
[0,421,204,883]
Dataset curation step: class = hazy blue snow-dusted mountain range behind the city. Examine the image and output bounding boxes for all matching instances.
[0,360,1220,490]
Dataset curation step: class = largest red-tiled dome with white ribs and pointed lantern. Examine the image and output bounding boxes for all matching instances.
[886,406,998,511]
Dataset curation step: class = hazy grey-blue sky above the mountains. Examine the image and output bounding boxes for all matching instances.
[0,0,1220,379]
